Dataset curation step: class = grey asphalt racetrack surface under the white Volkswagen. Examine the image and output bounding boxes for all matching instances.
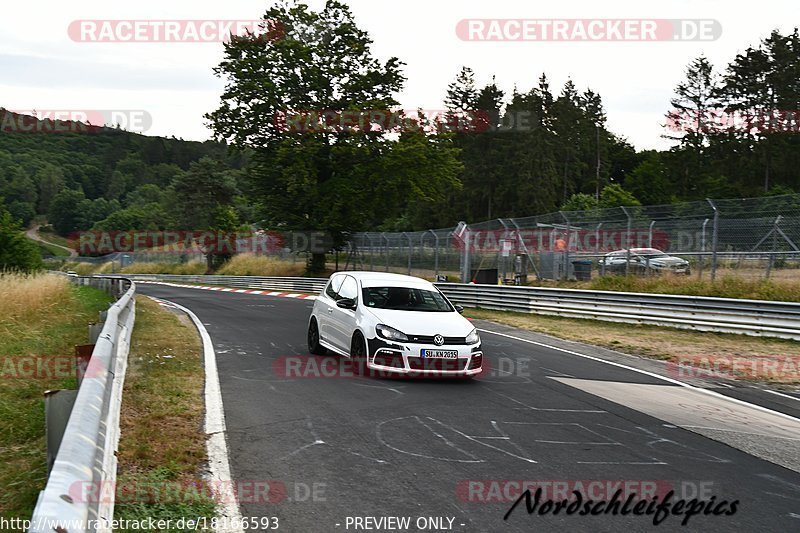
[138,284,800,532]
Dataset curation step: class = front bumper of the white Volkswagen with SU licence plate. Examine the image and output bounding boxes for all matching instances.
[367,338,483,376]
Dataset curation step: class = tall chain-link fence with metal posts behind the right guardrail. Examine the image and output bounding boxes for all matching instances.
[346,194,800,283]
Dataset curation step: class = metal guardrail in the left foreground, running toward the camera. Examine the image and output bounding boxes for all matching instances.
[28,277,136,533]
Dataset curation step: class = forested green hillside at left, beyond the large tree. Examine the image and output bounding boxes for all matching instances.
[0,108,238,233]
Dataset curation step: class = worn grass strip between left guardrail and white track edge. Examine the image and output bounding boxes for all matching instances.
[114,297,216,531]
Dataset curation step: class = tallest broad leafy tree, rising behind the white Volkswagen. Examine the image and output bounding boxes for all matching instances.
[206,0,460,271]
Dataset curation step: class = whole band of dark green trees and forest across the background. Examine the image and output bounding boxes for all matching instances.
[0,2,800,254]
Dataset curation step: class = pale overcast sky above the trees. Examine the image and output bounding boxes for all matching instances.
[0,0,800,149]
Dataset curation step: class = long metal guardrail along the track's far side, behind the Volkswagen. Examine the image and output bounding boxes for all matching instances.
[126,274,800,340]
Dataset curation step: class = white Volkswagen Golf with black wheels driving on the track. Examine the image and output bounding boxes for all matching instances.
[308,272,483,376]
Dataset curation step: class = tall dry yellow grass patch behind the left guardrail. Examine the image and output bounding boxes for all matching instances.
[0,274,71,323]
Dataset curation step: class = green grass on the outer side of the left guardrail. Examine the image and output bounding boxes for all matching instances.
[0,278,110,518]
